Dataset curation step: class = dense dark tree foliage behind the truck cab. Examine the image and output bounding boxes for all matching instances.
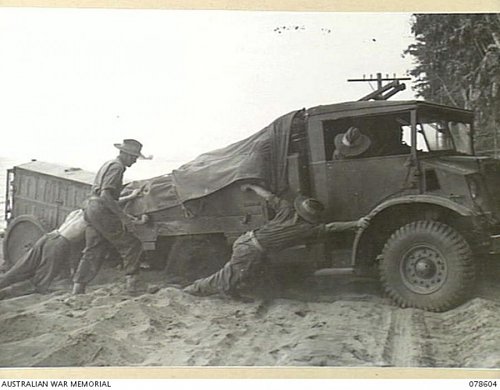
[406,14,500,150]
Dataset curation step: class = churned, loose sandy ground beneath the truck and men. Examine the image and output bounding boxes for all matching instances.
[0,256,500,368]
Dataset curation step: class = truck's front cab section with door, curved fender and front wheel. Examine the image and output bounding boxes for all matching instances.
[289,101,500,311]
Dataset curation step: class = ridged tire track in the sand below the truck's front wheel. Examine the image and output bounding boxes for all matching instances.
[382,309,435,367]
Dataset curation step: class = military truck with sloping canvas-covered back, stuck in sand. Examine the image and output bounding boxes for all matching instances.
[6,93,500,311]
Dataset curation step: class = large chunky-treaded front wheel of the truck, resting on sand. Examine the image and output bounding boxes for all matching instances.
[379,221,475,312]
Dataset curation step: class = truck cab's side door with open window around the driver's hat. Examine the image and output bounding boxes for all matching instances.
[309,116,410,221]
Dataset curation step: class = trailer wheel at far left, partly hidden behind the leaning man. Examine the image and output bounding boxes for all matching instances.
[3,215,48,267]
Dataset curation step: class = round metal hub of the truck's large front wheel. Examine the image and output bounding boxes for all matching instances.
[400,245,447,294]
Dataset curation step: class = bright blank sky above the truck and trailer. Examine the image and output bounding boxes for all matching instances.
[0,8,414,178]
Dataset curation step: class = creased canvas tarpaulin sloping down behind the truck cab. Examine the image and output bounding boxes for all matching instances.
[123,111,297,215]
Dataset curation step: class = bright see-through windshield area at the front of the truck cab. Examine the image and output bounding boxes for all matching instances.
[403,120,472,154]
